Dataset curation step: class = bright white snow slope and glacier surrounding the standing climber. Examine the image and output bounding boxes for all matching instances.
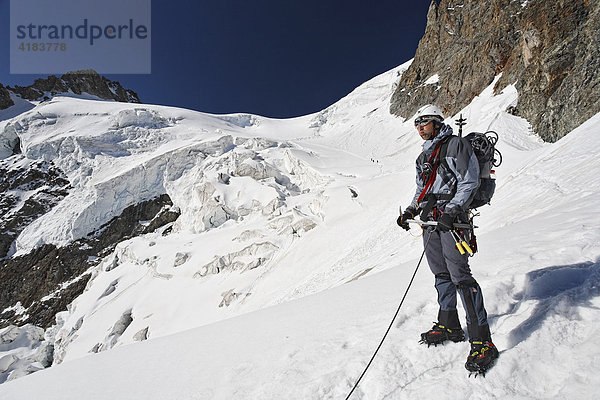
[0,64,600,400]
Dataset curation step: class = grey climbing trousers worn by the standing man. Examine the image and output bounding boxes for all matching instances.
[423,228,491,341]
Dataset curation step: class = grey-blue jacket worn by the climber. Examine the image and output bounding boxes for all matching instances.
[411,125,479,215]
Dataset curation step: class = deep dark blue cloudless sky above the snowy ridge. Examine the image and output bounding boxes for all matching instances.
[0,0,430,117]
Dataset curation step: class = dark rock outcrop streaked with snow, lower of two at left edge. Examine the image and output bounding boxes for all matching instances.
[0,194,179,328]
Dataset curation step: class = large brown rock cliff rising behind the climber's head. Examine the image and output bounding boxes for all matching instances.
[390,0,600,141]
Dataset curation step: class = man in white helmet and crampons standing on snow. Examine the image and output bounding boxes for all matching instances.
[397,105,498,372]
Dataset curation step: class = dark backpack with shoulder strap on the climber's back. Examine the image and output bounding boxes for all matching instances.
[440,131,502,208]
